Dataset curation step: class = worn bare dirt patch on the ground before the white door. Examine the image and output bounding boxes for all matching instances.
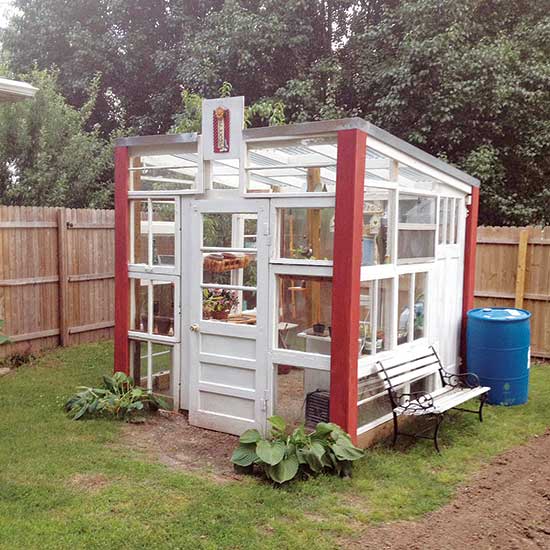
[122,412,241,481]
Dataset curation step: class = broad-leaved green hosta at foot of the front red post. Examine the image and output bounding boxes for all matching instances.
[231,416,364,483]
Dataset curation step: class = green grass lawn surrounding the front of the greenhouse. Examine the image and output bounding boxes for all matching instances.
[0,344,550,550]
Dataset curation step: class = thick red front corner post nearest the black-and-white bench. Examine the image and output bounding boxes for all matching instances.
[330,130,367,441]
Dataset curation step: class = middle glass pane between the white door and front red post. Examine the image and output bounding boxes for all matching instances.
[277,275,332,355]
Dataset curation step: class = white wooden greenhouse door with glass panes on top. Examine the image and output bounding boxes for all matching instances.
[188,199,269,435]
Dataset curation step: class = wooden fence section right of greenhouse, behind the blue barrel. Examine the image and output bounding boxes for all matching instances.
[475,227,550,358]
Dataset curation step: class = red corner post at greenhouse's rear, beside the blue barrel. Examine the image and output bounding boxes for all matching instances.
[460,187,479,372]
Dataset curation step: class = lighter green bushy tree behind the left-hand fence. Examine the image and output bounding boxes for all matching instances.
[0,71,113,208]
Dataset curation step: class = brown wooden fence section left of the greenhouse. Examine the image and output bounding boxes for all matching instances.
[0,206,114,357]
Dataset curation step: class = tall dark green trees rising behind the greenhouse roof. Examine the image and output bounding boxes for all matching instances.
[3,0,550,224]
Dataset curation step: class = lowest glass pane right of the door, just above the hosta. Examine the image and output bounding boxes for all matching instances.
[273,365,330,428]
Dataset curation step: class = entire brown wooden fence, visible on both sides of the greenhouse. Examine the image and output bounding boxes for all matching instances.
[0,215,550,358]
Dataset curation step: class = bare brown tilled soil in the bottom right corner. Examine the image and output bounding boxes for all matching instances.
[348,431,550,550]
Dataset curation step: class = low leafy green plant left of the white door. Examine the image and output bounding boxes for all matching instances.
[65,372,169,421]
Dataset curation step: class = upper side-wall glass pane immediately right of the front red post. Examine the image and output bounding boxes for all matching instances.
[362,187,394,265]
